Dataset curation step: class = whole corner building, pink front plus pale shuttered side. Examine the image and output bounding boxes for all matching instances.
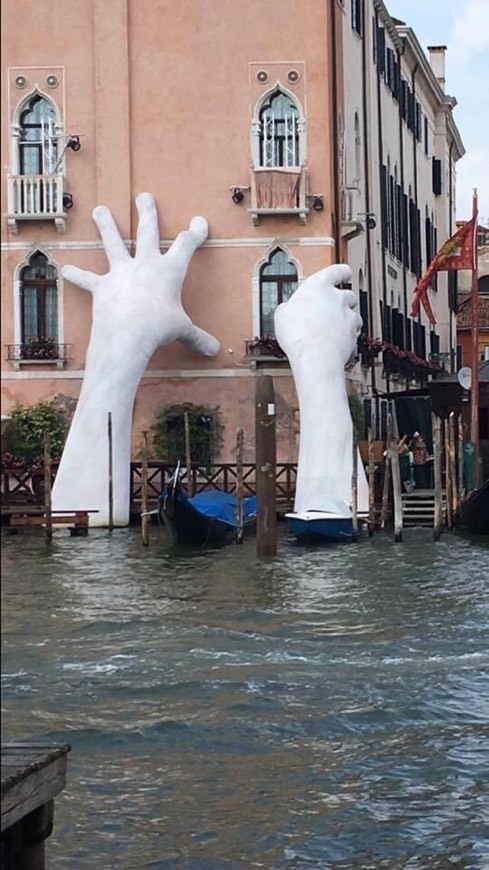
[1,0,469,461]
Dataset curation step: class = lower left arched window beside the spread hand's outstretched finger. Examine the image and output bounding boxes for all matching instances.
[19,251,58,345]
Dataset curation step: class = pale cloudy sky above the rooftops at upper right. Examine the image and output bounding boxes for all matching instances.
[385,0,489,224]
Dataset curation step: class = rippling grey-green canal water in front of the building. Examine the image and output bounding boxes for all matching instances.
[2,527,489,870]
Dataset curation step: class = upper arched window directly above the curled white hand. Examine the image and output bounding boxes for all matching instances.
[260,91,300,168]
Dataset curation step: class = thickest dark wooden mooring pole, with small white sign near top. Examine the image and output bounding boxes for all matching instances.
[255,375,277,556]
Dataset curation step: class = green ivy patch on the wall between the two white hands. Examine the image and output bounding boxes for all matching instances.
[151,402,224,466]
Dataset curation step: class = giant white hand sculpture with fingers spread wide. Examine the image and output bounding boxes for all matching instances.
[53,193,220,526]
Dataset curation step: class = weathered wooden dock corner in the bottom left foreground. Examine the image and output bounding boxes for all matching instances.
[1,743,71,870]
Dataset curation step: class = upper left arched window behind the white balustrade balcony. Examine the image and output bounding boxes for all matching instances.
[19,94,58,175]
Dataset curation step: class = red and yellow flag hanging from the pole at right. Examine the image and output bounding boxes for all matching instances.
[411,215,477,325]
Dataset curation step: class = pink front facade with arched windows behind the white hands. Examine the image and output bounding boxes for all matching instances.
[1,0,342,461]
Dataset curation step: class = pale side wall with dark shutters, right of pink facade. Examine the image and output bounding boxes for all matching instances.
[338,0,464,430]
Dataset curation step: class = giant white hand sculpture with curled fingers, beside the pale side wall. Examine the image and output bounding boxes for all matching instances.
[275,265,368,515]
